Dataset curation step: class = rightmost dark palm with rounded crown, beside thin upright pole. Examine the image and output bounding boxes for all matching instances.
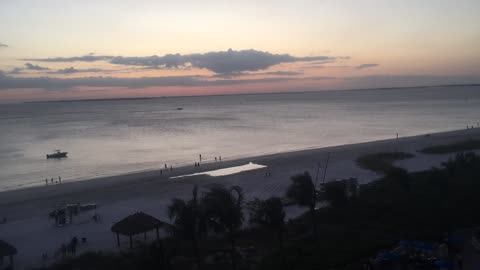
[287,172,318,240]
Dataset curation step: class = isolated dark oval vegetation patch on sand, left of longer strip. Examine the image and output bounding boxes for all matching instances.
[357,152,414,174]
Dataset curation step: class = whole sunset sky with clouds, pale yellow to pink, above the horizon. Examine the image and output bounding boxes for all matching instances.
[0,0,480,102]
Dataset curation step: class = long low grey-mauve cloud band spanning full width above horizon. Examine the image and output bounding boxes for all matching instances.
[0,71,480,91]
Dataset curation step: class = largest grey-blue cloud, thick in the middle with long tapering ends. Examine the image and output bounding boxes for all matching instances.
[20,49,342,74]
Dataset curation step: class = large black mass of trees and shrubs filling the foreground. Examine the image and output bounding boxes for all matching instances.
[38,153,480,270]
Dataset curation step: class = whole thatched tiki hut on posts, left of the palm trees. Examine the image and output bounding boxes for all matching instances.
[111,212,168,248]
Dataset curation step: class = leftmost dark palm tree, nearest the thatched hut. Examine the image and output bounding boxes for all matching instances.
[168,186,206,268]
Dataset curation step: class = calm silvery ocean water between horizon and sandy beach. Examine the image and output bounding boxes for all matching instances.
[0,86,480,190]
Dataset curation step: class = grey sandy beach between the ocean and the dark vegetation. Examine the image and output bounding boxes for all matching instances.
[0,128,480,269]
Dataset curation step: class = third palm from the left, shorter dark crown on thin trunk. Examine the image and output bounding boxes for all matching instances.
[249,197,285,252]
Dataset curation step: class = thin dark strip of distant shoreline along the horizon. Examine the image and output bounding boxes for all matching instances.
[21,83,480,104]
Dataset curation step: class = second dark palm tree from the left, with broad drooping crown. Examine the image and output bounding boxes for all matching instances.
[203,185,244,269]
